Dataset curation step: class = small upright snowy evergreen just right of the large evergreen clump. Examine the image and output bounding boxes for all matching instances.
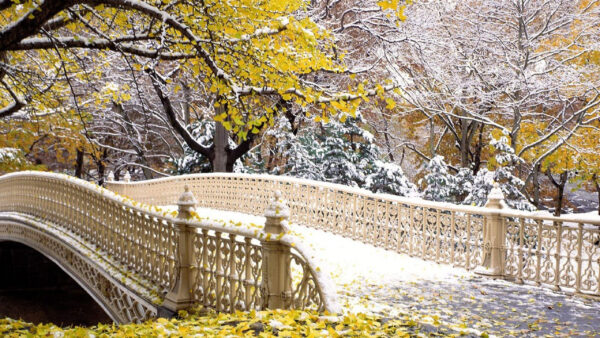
[423,155,456,202]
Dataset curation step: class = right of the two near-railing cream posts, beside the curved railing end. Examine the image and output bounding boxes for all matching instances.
[262,191,292,309]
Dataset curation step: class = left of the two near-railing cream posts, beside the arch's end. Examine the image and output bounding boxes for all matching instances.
[163,185,197,312]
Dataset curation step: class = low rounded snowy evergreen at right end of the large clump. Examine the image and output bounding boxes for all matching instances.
[365,161,419,196]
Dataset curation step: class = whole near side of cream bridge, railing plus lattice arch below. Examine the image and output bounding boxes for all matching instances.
[0,172,338,322]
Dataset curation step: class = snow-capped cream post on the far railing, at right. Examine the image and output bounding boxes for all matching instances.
[475,183,506,277]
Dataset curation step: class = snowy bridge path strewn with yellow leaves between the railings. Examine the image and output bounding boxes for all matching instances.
[192,208,600,337]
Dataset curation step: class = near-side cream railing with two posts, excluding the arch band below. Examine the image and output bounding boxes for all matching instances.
[0,172,340,320]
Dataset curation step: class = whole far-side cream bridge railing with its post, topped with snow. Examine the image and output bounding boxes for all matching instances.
[106,173,600,297]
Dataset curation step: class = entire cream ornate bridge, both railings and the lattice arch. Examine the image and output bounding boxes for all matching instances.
[0,172,600,322]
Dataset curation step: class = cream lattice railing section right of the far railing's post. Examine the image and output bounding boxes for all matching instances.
[502,212,600,297]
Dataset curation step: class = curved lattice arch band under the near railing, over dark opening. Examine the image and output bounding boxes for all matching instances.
[0,214,158,323]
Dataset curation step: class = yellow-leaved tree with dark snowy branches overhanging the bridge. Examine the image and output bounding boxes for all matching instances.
[0,0,404,172]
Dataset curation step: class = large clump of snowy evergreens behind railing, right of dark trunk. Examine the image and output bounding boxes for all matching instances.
[260,113,418,196]
